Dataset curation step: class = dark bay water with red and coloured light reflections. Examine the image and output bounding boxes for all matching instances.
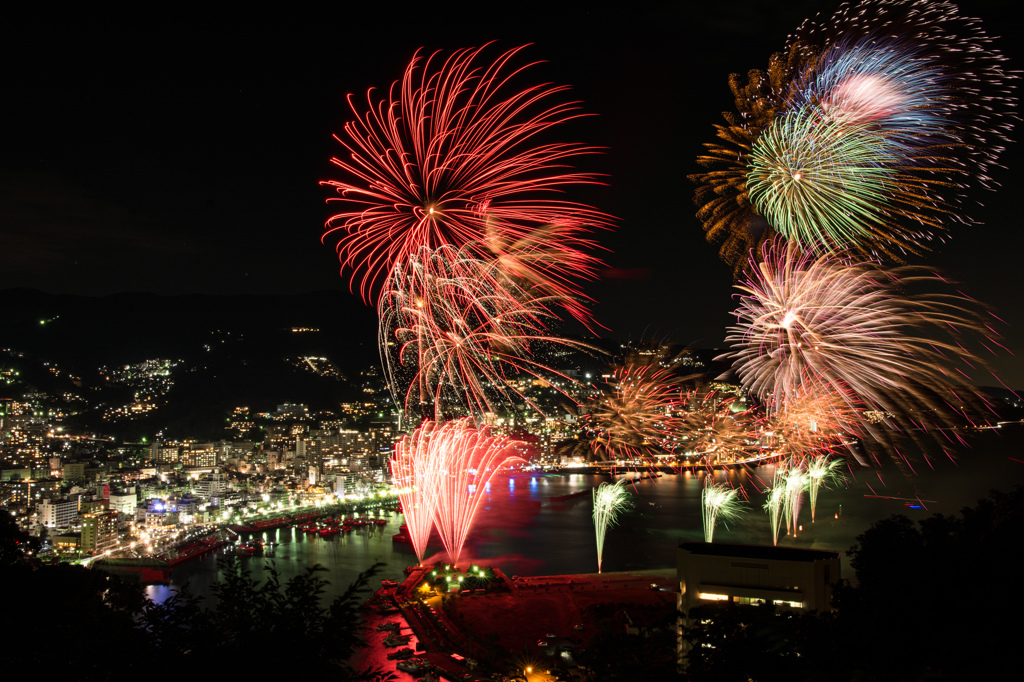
[147,425,1024,601]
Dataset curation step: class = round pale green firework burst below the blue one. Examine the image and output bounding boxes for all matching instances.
[746,106,896,252]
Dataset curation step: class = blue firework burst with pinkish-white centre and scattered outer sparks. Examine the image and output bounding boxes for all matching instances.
[790,0,1019,186]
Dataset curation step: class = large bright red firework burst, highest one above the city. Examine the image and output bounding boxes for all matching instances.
[323,48,610,315]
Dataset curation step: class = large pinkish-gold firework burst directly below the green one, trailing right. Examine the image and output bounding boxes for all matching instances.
[724,236,986,464]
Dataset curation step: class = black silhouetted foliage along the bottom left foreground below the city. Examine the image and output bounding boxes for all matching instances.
[0,544,392,681]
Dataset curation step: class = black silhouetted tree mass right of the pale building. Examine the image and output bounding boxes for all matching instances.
[838,487,1024,680]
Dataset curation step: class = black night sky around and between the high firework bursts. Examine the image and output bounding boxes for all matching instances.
[0,0,1024,388]
